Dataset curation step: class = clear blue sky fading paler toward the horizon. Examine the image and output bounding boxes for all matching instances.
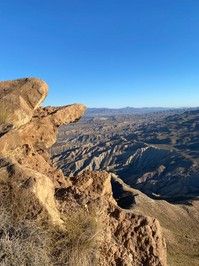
[0,0,199,107]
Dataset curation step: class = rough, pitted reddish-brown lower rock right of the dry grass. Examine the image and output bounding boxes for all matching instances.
[56,171,167,266]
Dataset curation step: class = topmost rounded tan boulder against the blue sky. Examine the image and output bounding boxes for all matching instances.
[0,78,48,128]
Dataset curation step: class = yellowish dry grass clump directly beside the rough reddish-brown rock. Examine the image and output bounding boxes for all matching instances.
[50,209,103,266]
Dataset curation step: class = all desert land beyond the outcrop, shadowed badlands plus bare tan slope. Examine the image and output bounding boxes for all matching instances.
[51,108,199,266]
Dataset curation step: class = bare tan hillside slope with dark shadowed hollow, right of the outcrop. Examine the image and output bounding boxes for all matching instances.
[112,174,199,266]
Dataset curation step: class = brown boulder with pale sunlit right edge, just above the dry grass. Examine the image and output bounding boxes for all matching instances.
[0,159,62,225]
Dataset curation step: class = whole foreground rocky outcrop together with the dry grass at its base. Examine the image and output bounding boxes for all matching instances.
[0,78,167,266]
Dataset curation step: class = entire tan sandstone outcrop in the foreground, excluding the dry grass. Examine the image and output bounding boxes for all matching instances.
[0,78,166,266]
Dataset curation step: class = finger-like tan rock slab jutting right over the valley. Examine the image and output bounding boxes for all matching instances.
[0,104,85,156]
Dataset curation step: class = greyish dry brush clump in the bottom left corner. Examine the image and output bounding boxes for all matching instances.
[0,209,52,266]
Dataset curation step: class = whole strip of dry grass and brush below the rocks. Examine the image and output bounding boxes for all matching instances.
[0,200,102,266]
